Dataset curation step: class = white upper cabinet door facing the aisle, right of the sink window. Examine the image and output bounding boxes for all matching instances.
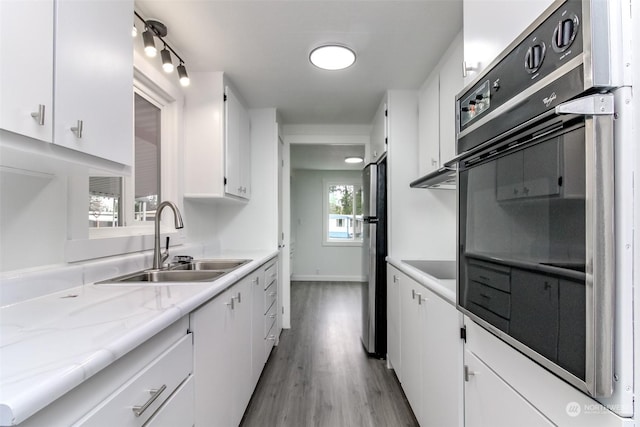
[225,86,251,198]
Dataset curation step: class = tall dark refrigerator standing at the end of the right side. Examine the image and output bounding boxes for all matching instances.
[361,157,387,358]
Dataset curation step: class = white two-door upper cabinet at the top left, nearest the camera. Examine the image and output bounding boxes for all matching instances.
[0,0,133,166]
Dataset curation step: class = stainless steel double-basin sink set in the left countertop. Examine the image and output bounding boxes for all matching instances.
[96,259,251,284]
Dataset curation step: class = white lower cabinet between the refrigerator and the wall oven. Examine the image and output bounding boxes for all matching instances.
[387,266,462,427]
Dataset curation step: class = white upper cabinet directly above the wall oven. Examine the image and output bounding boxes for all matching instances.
[460,0,553,85]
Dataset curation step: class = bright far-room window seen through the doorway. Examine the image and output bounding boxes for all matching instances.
[324,182,363,245]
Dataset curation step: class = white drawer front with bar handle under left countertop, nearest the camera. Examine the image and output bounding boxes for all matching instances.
[74,334,193,427]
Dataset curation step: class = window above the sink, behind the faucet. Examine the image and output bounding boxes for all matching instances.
[89,89,162,228]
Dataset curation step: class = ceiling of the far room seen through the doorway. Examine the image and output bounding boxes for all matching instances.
[290,144,364,170]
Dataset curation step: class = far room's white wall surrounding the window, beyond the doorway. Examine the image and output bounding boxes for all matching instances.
[291,169,364,281]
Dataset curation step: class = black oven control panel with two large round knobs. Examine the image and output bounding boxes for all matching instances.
[457,0,584,137]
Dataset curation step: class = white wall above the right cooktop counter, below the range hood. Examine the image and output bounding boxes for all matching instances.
[387,90,456,260]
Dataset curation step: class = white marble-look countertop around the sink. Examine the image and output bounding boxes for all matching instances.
[0,251,277,425]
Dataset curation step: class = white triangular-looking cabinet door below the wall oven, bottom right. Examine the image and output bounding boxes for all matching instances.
[464,350,553,427]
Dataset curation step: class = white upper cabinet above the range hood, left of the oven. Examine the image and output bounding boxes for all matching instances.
[418,33,463,176]
